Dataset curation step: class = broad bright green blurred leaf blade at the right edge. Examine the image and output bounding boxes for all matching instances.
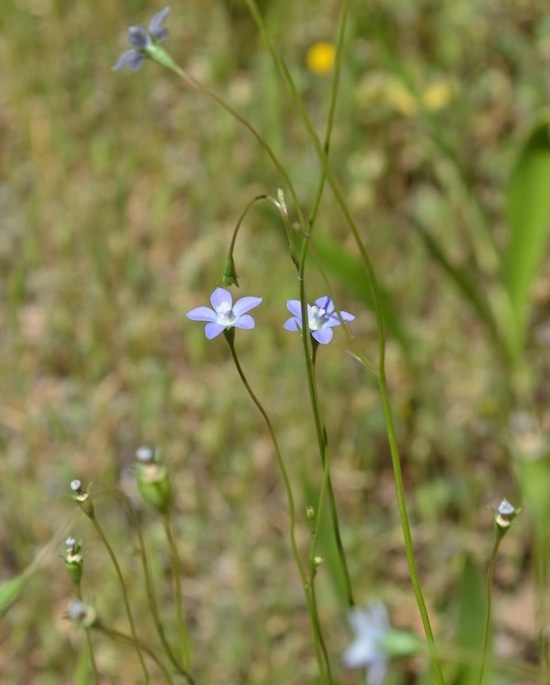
[503,111,550,350]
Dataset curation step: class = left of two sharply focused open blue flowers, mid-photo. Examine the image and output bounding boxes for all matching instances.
[185,288,262,340]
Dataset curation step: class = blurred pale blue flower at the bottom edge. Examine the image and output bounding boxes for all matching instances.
[343,602,392,685]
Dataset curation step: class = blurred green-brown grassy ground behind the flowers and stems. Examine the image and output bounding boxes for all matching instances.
[0,0,550,685]
